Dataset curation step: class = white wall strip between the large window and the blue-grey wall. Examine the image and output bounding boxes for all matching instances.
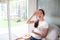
[28,0,36,33]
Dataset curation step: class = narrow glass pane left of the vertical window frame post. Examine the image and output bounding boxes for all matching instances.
[0,2,9,40]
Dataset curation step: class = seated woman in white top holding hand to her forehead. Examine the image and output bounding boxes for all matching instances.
[27,9,48,40]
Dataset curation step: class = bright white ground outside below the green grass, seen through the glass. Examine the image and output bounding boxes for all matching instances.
[0,24,28,40]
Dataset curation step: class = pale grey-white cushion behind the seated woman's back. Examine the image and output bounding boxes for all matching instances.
[43,24,59,40]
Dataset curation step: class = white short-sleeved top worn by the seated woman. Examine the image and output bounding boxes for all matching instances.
[31,16,48,39]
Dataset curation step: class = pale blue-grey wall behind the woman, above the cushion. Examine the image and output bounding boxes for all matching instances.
[38,0,60,26]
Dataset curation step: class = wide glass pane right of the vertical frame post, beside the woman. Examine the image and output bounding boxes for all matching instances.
[9,0,28,40]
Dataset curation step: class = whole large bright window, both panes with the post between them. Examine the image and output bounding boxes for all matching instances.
[0,0,28,40]
